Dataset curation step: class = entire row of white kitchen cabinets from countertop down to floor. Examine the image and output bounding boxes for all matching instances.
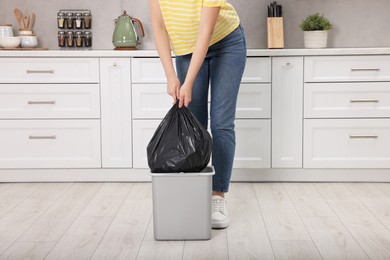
[0,49,390,182]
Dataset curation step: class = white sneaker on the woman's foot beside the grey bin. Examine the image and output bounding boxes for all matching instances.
[211,195,230,229]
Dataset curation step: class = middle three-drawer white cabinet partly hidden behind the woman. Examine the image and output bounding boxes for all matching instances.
[131,58,271,168]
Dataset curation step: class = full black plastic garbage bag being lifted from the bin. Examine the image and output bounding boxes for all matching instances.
[147,102,212,173]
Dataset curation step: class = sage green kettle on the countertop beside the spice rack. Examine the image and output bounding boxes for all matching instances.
[112,11,145,49]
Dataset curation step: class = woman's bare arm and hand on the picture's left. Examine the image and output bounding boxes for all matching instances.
[149,0,180,103]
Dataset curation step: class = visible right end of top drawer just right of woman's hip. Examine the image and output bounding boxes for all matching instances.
[242,57,271,83]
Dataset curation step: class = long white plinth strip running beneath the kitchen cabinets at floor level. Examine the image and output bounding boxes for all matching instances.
[0,169,390,182]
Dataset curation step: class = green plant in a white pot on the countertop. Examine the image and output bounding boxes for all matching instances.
[300,13,332,48]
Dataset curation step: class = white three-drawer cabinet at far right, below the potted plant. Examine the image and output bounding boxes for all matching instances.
[303,56,390,169]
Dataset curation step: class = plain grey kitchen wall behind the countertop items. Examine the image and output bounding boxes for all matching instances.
[0,0,390,49]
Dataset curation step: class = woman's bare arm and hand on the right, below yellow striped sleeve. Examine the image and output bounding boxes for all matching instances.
[179,6,221,107]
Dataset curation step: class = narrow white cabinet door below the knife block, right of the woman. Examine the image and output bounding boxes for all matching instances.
[272,57,303,168]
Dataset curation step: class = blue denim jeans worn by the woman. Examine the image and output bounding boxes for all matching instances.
[176,26,246,192]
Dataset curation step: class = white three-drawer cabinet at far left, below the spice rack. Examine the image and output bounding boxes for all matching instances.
[0,58,101,169]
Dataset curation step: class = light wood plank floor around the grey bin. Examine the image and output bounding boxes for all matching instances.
[0,183,390,260]
